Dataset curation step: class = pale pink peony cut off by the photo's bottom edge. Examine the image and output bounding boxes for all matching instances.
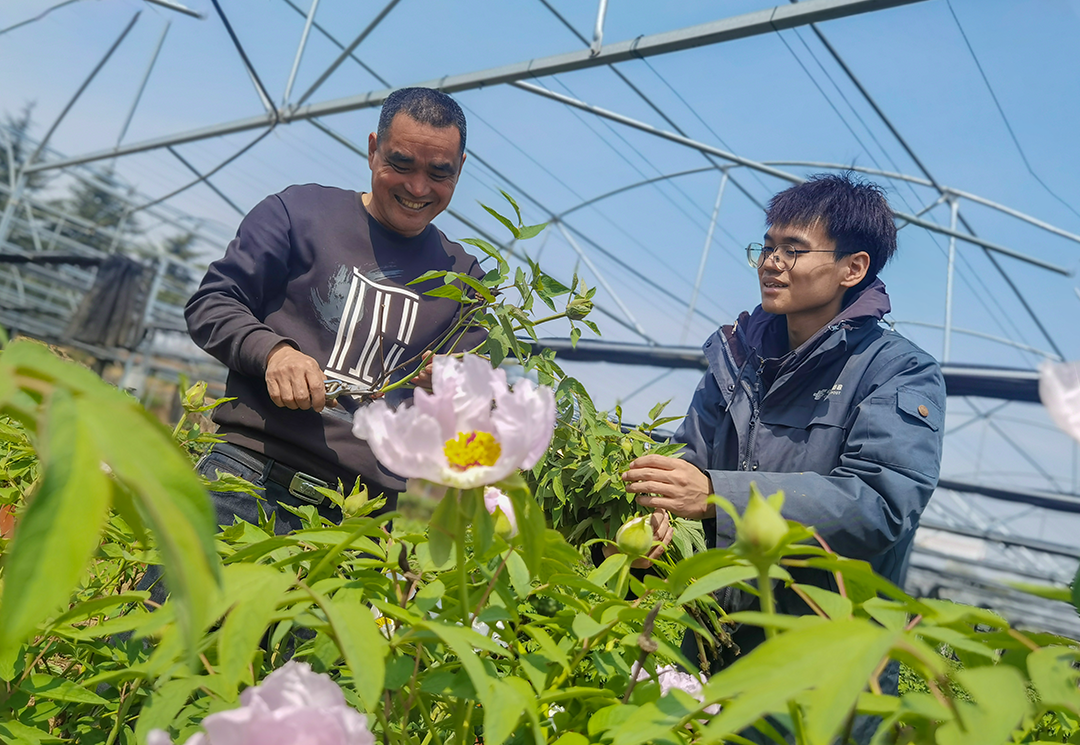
[147,661,375,745]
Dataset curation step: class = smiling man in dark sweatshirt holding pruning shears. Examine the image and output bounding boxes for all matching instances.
[186,89,484,531]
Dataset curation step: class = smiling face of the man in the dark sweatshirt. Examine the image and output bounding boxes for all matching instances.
[364,113,464,238]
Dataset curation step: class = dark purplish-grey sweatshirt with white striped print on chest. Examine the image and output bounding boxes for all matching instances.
[185,184,484,490]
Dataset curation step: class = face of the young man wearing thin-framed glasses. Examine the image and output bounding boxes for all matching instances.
[757,224,865,338]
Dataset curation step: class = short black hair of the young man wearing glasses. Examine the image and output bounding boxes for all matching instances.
[765,172,896,289]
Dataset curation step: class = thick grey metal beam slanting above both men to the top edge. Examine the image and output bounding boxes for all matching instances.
[31,0,924,172]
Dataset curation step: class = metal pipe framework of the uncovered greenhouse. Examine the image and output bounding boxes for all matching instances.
[0,0,1080,617]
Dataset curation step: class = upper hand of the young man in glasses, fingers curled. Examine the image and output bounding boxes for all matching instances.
[622,456,716,519]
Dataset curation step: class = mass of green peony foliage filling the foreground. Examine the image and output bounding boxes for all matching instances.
[0,201,1080,745]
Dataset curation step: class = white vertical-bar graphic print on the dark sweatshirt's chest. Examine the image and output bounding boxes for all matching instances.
[312,267,420,388]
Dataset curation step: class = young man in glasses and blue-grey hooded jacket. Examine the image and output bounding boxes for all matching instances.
[623,175,945,712]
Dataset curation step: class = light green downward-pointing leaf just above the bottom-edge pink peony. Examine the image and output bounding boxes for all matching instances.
[217,564,294,701]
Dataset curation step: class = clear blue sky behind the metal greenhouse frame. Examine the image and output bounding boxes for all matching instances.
[0,0,1080,557]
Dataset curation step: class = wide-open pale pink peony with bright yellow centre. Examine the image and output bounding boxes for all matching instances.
[352,354,555,489]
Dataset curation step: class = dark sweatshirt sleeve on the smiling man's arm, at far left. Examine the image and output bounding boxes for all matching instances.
[184,195,299,378]
